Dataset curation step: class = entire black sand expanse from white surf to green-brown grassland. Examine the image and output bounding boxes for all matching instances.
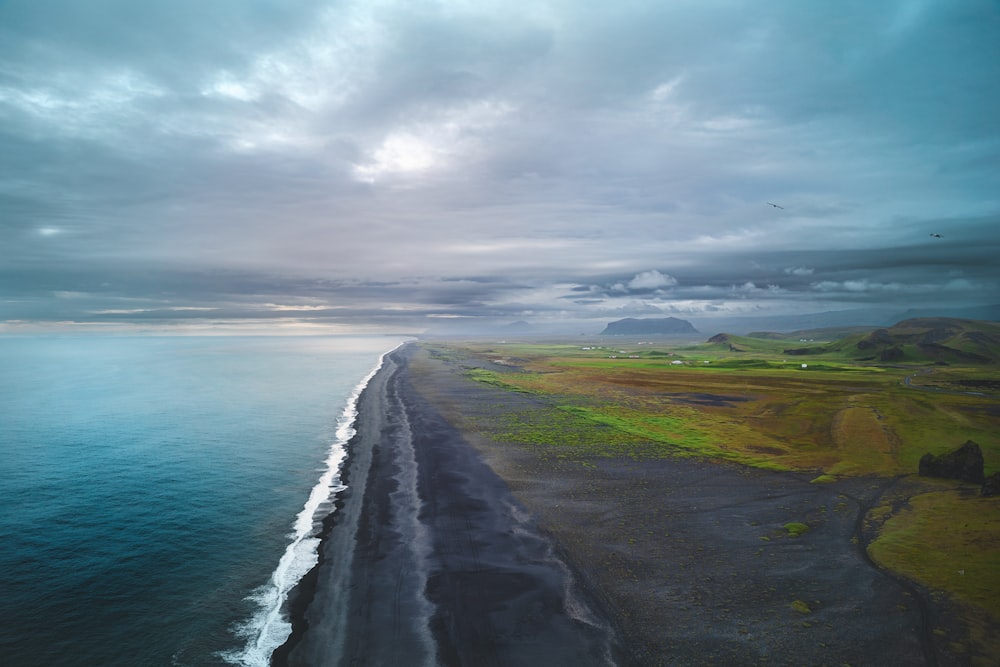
[274,344,963,667]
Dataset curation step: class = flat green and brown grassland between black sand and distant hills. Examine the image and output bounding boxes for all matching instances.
[425,339,1000,656]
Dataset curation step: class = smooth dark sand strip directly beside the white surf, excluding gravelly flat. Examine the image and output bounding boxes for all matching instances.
[272,344,620,667]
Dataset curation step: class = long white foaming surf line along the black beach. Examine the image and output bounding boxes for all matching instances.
[220,344,402,667]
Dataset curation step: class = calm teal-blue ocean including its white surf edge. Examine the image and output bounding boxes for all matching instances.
[0,335,403,667]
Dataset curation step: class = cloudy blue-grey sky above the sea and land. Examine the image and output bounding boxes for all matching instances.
[0,0,1000,332]
